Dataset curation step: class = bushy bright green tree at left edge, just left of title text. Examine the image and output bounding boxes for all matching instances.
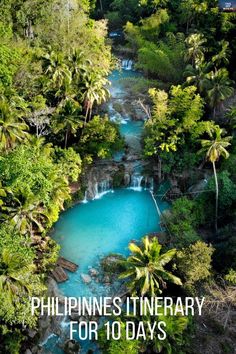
[0,228,45,328]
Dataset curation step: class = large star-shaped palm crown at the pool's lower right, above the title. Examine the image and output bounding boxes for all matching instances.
[120,236,182,296]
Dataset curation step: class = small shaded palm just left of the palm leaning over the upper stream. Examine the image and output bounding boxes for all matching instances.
[54,98,83,148]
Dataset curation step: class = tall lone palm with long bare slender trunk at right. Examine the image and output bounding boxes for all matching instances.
[200,126,232,232]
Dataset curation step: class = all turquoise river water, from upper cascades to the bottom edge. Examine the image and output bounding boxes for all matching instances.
[43,70,168,354]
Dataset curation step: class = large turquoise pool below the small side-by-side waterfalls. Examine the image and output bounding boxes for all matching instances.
[54,189,167,296]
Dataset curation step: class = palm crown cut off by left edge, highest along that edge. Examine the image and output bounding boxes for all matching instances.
[0,99,28,151]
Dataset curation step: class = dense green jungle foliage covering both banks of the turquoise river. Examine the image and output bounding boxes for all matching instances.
[0,0,236,354]
